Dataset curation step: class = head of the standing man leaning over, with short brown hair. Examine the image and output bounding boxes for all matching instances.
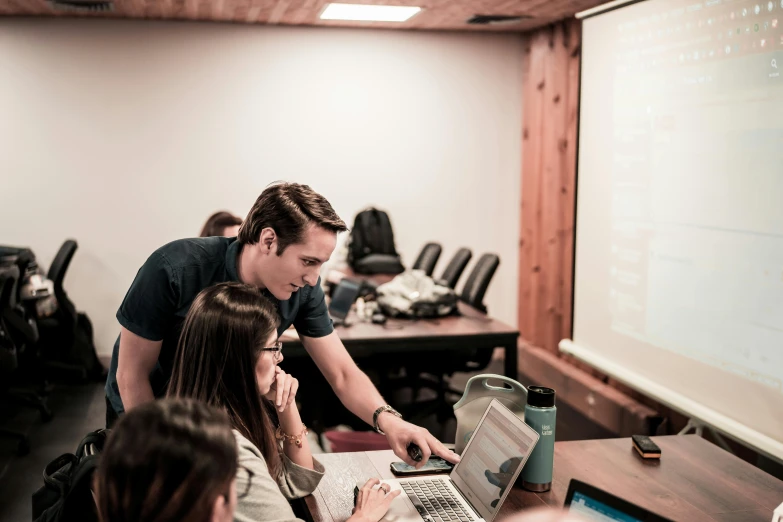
[237,183,348,300]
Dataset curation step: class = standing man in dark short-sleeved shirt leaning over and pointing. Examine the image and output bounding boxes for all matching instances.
[106,183,459,467]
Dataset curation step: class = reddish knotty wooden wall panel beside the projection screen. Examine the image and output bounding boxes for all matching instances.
[519,20,581,351]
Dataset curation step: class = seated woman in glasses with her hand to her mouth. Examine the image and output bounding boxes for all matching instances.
[168,283,399,522]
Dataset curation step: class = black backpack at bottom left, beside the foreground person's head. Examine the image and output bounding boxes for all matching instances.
[33,429,109,522]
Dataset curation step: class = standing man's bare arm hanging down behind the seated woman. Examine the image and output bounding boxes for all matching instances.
[117,327,163,411]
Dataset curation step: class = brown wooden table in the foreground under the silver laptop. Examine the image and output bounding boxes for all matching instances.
[305,435,783,522]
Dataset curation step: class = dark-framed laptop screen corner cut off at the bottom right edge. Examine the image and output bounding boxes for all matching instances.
[565,479,672,522]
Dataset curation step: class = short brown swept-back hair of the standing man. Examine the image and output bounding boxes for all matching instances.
[237,183,348,255]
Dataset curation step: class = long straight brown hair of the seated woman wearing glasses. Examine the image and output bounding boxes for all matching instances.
[168,283,282,477]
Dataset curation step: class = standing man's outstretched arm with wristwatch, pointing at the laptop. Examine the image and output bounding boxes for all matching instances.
[300,332,459,467]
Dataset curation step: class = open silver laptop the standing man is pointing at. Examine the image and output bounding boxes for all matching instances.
[382,399,539,522]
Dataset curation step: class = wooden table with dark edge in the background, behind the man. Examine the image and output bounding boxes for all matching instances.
[281,303,519,379]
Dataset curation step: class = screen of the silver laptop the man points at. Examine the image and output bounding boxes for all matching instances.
[451,400,539,520]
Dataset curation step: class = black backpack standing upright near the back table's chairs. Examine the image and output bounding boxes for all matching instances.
[348,208,405,274]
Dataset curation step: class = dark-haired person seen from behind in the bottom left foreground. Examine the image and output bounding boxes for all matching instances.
[93,399,237,522]
